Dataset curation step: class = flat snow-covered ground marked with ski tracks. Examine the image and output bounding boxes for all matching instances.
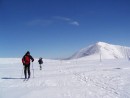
[0,59,130,98]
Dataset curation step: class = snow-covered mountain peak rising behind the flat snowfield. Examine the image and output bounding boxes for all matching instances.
[69,42,130,59]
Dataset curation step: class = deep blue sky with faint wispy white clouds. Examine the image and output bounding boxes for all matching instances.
[0,0,130,58]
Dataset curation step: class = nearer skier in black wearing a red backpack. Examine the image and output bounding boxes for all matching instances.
[22,51,34,79]
